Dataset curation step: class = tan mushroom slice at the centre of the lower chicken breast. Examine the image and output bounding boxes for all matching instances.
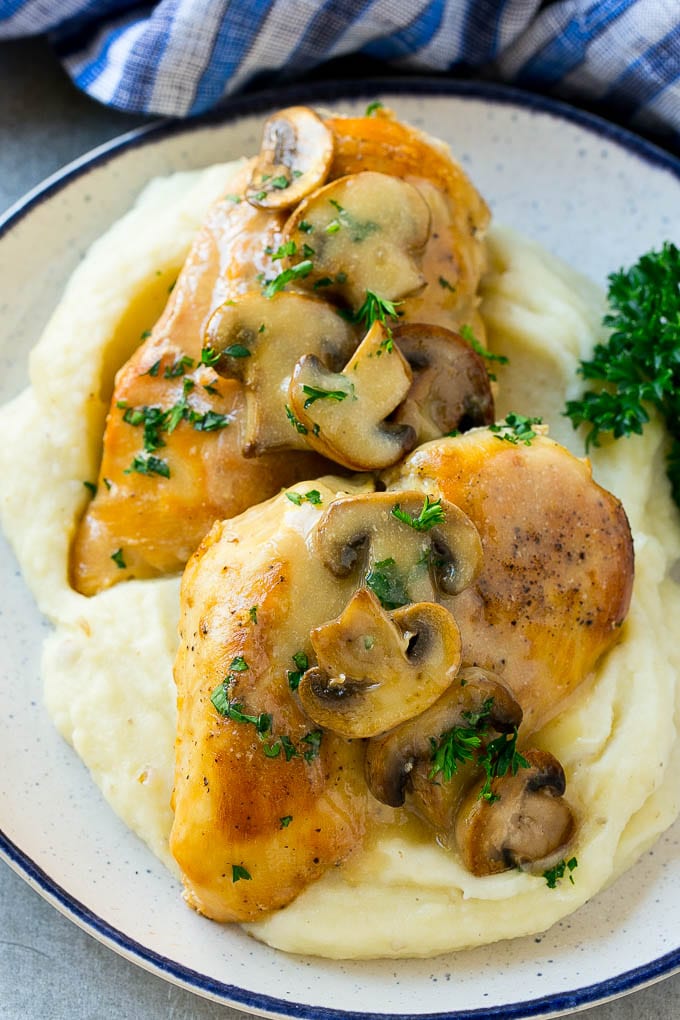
[298,588,461,737]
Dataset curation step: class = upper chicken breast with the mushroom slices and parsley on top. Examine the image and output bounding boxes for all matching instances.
[71,107,491,595]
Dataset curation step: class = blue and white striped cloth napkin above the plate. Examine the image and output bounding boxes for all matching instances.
[0,0,680,145]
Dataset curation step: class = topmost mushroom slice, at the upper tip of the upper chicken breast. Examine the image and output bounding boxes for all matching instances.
[246,106,333,209]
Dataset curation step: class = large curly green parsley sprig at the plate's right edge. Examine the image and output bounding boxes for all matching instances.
[565,241,680,506]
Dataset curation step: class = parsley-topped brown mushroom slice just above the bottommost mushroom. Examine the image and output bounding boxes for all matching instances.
[365,667,522,807]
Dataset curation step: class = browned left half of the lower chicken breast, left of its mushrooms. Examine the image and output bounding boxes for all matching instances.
[170,482,368,921]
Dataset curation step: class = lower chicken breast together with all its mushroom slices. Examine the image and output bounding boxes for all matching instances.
[171,426,633,920]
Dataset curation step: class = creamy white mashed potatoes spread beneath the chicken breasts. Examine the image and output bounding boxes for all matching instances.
[0,164,680,958]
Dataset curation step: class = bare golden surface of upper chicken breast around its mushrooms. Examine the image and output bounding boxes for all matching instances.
[70,108,488,595]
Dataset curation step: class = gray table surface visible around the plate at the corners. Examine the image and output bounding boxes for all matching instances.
[0,39,680,1020]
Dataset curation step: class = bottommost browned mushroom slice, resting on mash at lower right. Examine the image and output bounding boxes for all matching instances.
[456,749,575,875]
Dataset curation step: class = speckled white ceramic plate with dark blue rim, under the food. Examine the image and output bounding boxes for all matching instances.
[0,81,680,1020]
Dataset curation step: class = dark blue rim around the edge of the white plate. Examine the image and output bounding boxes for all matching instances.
[0,78,680,1020]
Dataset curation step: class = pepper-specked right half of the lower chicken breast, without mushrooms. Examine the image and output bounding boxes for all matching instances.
[388,429,633,735]
